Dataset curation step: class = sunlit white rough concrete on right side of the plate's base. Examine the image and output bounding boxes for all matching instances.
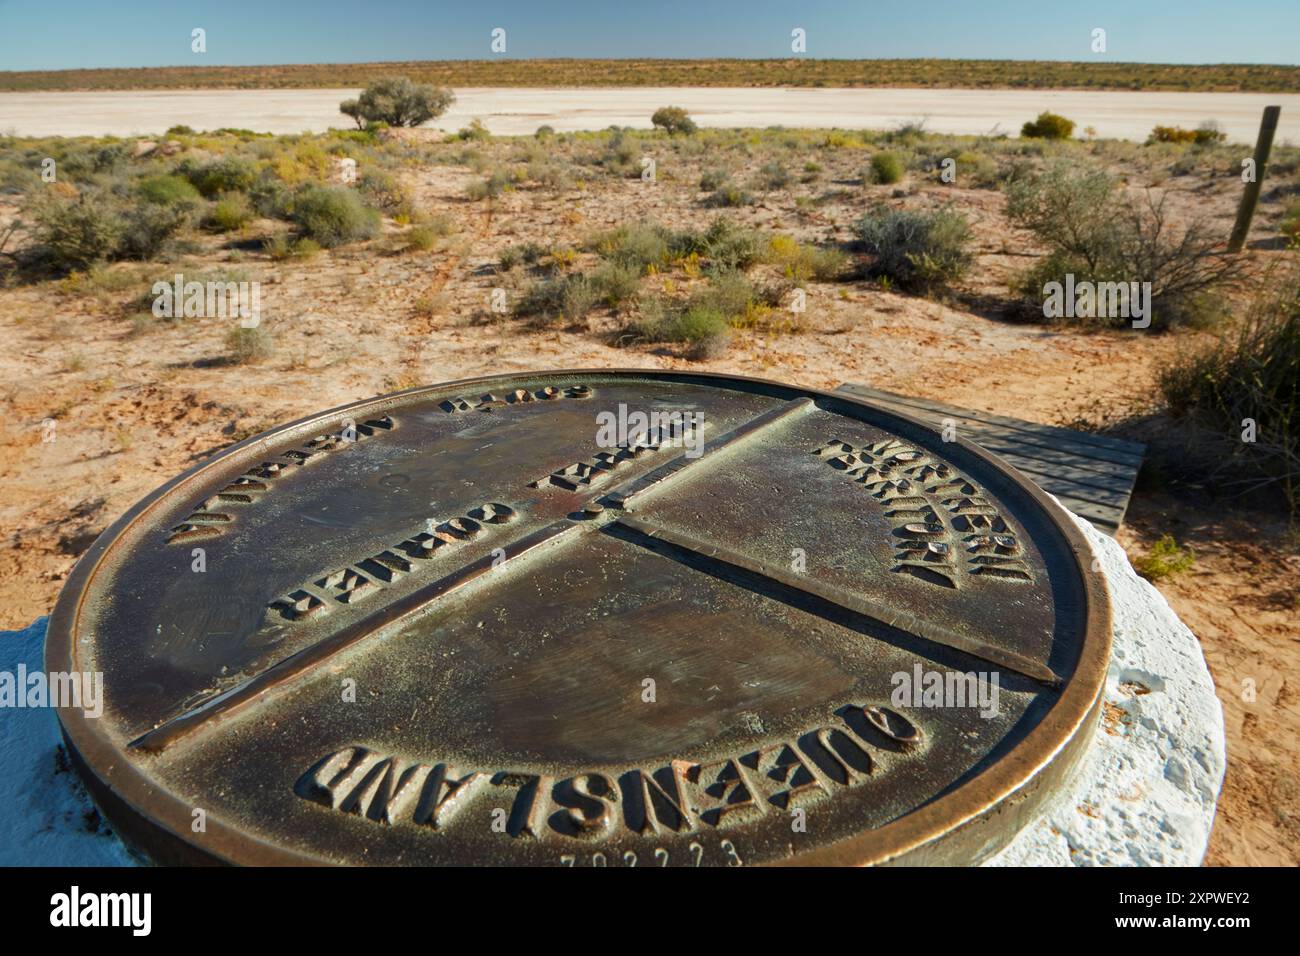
[985,518,1226,866]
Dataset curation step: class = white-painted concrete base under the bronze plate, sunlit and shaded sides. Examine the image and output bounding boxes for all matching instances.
[0,509,1225,866]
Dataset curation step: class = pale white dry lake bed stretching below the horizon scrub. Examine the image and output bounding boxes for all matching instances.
[0,87,1300,143]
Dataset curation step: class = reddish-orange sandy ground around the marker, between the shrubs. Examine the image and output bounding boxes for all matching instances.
[0,127,1300,865]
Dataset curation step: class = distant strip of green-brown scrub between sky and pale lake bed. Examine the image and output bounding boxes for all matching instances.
[0,59,1300,92]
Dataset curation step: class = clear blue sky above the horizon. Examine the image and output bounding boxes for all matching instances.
[0,0,1300,70]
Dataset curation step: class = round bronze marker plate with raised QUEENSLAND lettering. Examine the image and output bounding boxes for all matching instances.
[47,371,1110,866]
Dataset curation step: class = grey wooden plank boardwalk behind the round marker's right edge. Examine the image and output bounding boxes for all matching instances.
[837,382,1147,537]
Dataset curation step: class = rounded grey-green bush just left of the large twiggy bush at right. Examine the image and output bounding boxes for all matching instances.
[854,206,971,293]
